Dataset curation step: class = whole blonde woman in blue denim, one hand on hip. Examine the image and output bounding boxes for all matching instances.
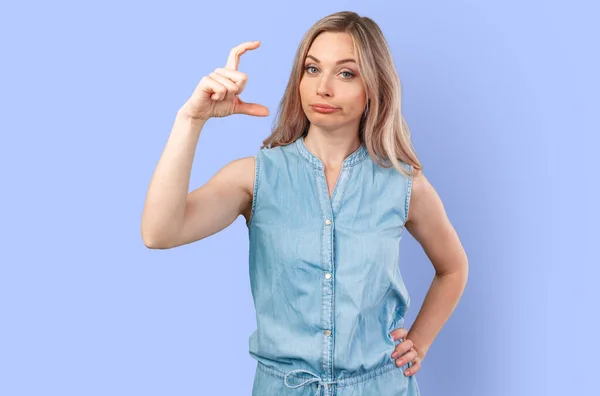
[142,12,468,396]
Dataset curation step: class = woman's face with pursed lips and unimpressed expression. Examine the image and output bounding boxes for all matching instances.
[299,32,366,128]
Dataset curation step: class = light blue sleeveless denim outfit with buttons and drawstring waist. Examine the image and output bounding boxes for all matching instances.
[247,137,419,396]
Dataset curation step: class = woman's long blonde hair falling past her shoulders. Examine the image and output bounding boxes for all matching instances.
[261,11,423,175]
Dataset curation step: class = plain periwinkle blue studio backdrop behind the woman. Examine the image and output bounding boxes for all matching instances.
[0,0,600,396]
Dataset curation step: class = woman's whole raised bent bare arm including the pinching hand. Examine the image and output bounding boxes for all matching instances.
[141,41,269,249]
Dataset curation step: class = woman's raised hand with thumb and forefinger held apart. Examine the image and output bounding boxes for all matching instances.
[184,41,269,120]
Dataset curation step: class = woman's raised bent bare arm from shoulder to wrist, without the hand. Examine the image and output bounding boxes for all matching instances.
[141,110,254,249]
